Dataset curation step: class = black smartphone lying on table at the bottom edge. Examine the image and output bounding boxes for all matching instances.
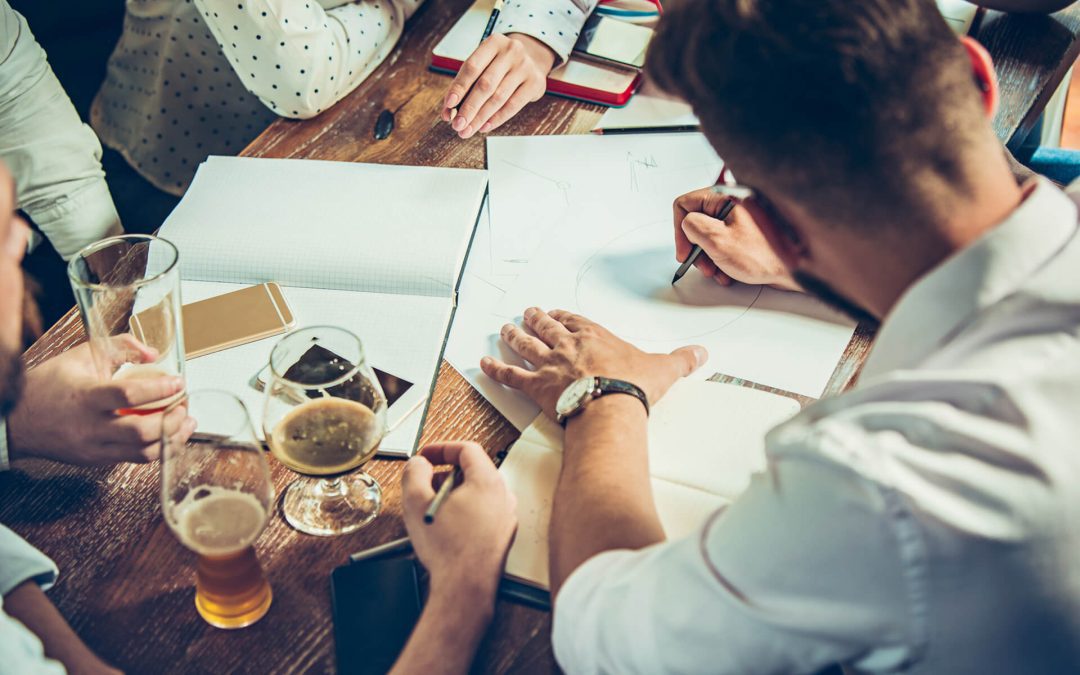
[330,557,420,675]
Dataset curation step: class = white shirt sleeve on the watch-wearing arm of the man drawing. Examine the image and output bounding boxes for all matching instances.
[552,459,917,674]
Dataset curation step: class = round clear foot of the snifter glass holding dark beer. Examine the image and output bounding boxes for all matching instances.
[282,471,382,537]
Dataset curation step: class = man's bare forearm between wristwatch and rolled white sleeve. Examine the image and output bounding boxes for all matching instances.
[550,395,664,596]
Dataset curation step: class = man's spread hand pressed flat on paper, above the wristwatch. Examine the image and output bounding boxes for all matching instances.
[480,307,707,417]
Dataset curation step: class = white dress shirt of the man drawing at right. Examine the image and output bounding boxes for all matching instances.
[553,180,1080,674]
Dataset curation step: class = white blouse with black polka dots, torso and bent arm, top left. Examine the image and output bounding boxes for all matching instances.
[91,0,423,194]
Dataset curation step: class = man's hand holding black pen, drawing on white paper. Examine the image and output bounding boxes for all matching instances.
[673,188,801,291]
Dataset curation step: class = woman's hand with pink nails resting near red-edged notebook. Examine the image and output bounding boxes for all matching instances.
[442,33,555,138]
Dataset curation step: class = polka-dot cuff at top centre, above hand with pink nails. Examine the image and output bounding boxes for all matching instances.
[495,0,599,67]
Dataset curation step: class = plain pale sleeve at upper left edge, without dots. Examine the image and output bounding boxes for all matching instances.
[0,1,122,259]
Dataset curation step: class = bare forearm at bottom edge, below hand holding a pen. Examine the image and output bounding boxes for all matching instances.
[391,580,498,675]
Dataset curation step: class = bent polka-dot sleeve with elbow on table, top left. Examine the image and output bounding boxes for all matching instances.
[195,0,423,119]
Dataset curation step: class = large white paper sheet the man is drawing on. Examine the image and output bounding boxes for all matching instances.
[488,134,854,397]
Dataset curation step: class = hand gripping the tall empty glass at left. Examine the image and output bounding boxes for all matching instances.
[8,336,194,465]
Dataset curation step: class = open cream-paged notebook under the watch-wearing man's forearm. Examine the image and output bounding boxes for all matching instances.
[500,380,799,591]
